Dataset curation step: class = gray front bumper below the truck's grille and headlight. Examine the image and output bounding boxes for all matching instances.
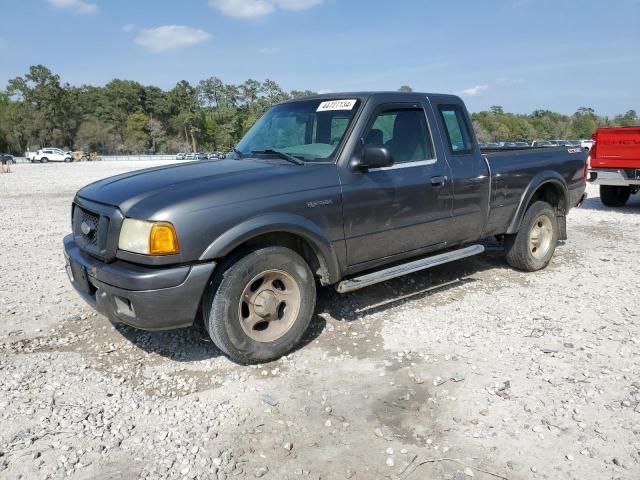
[64,235,216,330]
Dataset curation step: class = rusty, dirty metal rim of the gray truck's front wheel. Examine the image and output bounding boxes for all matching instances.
[238,270,302,342]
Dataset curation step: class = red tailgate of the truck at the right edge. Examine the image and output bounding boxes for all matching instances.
[591,126,640,168]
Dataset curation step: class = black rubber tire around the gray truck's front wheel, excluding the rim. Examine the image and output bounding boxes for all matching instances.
[202,247,316,364]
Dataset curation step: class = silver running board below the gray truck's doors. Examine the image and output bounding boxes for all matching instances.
[336,245,484,293]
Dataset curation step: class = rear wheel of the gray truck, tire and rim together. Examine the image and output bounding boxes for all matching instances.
[504,201,558,272]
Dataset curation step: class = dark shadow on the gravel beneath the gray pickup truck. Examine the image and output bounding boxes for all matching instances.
[116,240,509,363]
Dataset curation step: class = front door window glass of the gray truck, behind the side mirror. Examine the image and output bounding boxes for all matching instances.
[365,109,435,163]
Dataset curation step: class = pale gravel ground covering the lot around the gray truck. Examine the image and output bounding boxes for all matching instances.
[0,162,640,480]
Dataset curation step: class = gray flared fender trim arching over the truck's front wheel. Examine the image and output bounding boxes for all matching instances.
[200,213,341,284]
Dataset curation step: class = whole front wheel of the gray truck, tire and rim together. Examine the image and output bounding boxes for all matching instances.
[203,247,316,364]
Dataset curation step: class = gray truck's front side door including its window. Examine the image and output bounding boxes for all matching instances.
[343,103,452,269]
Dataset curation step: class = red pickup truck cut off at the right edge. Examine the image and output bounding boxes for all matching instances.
[588,126,640,207]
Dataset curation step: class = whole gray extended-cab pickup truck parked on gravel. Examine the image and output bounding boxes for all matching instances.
[64,92,586,363]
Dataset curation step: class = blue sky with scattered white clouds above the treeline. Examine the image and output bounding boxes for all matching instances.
[0,0,640,115]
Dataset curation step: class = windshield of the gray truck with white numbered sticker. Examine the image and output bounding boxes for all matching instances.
[235,99,360,162]
